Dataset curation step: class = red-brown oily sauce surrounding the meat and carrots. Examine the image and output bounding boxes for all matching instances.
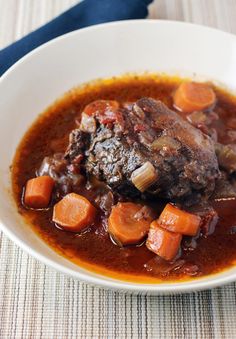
[12,76,236,282]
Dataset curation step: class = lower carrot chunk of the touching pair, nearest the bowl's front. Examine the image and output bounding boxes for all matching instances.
[146,220,182,260]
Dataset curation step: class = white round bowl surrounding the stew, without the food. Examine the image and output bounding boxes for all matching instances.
[0,20,236,294]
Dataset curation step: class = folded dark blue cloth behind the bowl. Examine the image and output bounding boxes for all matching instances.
[0,0,152,76]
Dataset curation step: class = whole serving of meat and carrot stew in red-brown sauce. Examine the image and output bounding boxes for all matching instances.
[12,75,236,282]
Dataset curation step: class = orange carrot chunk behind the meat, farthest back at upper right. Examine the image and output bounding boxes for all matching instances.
[174,82,216,113]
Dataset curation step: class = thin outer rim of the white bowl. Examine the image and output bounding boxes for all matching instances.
[0,19,236,295]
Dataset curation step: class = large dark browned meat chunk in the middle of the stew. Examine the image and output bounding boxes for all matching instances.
[65,98,219,204]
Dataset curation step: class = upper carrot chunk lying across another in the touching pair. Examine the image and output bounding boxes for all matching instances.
[158,204,201,236]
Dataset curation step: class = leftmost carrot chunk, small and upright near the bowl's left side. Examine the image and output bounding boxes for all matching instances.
[24,175,54,208]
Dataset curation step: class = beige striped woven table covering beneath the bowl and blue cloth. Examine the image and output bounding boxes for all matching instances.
[0,0,236,339]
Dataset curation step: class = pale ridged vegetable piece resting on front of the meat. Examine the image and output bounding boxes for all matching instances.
[131,161,158,192]
